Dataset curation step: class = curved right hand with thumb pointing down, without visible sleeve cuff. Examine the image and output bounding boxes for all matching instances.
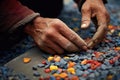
[81,0,110,48]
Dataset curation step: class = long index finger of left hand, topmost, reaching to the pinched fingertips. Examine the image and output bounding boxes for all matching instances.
[58,24,87,50]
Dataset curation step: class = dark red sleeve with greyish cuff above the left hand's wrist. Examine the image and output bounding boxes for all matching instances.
[0,0,39,33]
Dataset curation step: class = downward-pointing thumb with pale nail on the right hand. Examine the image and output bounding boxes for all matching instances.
[81,8,91,28]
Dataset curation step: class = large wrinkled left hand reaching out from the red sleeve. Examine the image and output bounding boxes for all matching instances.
[25,17,87,54]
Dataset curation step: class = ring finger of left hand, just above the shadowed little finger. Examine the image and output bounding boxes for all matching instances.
[45,39,64,54]
